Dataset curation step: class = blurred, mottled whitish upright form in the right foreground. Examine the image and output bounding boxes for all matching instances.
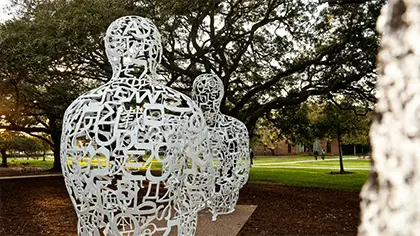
[359,0,420,236]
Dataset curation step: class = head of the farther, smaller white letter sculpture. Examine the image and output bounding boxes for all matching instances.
[192,74,224,113]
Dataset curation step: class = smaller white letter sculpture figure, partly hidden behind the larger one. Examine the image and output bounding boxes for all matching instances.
[192,74,250,220]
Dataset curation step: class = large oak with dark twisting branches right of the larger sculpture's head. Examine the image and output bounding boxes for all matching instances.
[149,1,383,131]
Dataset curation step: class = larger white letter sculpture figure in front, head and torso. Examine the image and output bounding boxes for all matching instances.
[61,16,214,236]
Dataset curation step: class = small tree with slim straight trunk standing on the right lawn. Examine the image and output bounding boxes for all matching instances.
[316,101,369,173]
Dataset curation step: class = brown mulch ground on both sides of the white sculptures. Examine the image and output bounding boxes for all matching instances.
[0,177,359,236]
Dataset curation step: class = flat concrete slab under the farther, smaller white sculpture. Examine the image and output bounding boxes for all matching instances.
[169,205,257,236]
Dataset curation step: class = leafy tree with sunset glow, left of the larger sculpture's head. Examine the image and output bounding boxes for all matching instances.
[0,0,141,170]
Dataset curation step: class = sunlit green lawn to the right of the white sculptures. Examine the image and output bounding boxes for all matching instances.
[249,156,371,192]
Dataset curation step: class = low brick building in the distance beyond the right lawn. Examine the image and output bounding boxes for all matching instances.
[253,139,339,156]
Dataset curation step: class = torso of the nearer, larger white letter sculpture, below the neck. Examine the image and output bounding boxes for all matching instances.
[62,75,210,234]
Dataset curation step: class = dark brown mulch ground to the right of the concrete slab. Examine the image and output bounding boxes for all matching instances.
[238,184,359,236]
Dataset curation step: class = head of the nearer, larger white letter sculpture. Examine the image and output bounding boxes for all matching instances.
[105,16,162,78]
